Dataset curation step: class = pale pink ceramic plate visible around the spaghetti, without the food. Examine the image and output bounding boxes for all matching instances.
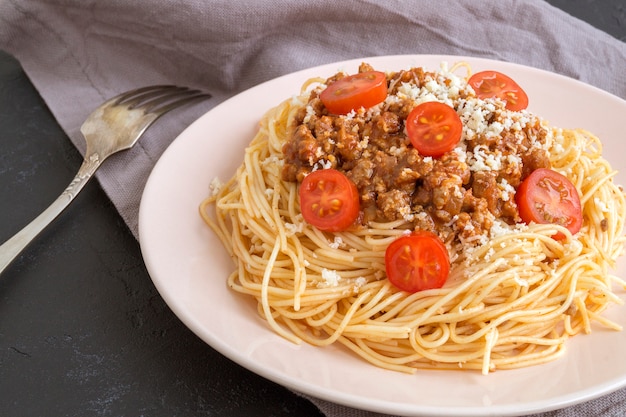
[139,55,626,416]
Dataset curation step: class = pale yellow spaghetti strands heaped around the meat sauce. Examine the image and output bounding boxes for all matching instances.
[200,62,626,374]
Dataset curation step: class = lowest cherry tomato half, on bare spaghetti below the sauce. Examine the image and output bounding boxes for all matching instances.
[385,231,450,293]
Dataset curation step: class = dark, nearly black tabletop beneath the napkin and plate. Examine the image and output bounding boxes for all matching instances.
[0,0,626,417]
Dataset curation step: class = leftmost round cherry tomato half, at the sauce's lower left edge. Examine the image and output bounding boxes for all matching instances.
[300,169,360,232]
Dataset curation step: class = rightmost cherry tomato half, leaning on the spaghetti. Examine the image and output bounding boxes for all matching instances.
[515,168,583,240]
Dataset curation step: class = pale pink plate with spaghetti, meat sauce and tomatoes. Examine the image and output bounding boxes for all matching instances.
[139,55,626,416]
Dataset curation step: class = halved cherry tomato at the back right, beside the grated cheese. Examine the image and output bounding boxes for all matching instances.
[467,71,528,111]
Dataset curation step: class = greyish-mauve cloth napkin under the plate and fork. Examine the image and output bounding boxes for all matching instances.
[0,0,626,417]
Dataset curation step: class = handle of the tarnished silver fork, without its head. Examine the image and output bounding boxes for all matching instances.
[0,154,102,274]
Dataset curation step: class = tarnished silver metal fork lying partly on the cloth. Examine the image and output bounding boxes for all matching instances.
[0,85,211,274]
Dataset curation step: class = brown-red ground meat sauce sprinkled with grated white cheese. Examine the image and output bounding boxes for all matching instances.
[282,64,550,242]
